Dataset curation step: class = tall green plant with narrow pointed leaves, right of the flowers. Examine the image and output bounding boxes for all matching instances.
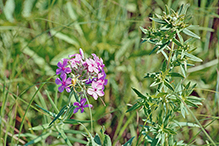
[127,4,216,146]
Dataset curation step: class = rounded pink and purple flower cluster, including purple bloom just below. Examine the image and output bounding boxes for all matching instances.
[55,49,107,112]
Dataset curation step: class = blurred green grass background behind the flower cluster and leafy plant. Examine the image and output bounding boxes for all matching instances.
[0,0,219,146]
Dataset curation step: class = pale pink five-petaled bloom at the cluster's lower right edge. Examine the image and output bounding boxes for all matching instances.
[87,81,104,100]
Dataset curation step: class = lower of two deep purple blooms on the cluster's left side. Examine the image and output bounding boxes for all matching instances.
[55,73,71,92]
